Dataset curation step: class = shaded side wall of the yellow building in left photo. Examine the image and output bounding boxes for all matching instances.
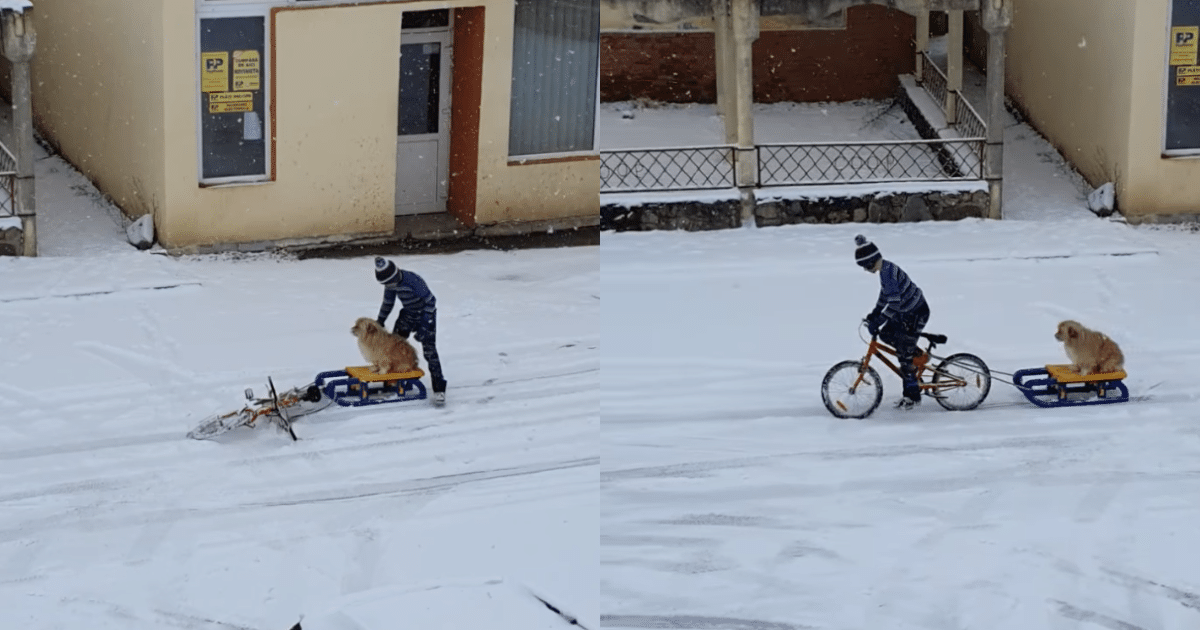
[31,0,166,223]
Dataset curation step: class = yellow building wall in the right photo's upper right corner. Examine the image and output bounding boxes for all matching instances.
[1006,0,1200,222]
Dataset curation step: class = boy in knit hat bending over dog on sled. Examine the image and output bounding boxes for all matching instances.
[376,257,446,406]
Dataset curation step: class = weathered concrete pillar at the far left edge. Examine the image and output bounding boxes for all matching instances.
[0,8,37,256]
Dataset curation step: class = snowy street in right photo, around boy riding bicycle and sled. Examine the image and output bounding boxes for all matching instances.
[600,220,1200,630]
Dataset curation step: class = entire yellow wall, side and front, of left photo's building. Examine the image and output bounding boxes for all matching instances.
[32,0,600,248]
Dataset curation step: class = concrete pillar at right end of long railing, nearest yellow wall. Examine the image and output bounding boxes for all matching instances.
[979,0,1013,218]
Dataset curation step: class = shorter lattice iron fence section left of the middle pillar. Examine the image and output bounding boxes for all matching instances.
[600,146,737,192]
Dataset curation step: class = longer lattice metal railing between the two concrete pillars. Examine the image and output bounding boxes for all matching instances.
[757,138,984,186]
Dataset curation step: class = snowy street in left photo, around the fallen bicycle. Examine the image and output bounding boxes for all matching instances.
[0,248,600,630]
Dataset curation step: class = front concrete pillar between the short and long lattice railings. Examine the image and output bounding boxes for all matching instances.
[732,0,758,223]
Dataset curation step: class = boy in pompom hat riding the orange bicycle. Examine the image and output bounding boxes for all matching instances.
[854,234,929,409]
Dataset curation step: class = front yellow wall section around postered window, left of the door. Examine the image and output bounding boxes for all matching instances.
[158,5,400,247]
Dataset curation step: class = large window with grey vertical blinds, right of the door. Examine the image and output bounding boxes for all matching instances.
[509,0,600,156]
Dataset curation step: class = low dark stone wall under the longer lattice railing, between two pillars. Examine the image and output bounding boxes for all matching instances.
[755,191,989,227]
